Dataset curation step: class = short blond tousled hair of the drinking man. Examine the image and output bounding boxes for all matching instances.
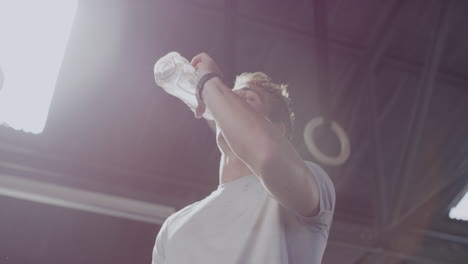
[233,72,294,139]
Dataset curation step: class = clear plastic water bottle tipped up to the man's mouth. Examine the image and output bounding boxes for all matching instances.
[154,51,213,120]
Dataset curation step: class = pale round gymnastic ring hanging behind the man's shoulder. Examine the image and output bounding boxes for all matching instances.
[304,117,351,166]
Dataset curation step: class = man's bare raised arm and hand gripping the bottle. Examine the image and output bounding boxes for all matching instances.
[192,53,320,216]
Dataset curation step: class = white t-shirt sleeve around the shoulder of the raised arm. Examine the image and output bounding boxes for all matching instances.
[297,161,335,232]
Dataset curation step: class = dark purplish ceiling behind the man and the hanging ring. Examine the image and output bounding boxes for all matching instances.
[0,0,468,263]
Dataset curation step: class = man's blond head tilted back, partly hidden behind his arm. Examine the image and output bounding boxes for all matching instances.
[233,72,294,139]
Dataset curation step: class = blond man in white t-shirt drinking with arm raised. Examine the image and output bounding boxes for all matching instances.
[153,53,335,264]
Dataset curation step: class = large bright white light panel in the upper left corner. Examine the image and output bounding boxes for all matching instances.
[0,0,78,134]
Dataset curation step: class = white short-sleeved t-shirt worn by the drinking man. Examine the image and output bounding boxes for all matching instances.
[153,161,335,264]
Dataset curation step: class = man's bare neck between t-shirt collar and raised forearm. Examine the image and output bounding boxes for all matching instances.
[219,152,253,184]
